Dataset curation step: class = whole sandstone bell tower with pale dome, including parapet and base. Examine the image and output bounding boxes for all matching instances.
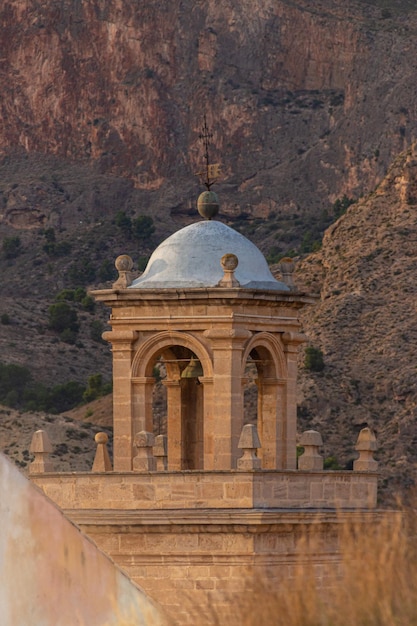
[32,191,377,626]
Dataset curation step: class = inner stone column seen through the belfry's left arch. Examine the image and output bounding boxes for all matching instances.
[162,380,183,471]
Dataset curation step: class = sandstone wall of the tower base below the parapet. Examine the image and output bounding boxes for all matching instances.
[73,511,375,626]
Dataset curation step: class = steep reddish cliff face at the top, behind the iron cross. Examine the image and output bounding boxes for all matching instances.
[0,0,417,233]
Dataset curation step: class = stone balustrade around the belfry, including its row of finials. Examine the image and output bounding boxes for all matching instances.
[30,424,378,510]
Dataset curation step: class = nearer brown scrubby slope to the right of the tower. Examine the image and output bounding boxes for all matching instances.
[298,147,417,500]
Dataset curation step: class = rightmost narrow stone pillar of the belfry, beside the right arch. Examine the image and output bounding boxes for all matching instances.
[282,332,307,469]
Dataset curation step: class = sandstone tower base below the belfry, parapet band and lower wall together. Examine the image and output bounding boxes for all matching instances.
[33,471,377,626]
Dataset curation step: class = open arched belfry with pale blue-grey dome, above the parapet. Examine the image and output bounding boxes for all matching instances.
[94,192,311,471]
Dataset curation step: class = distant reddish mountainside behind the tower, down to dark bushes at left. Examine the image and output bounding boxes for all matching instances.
[0,0,417,390]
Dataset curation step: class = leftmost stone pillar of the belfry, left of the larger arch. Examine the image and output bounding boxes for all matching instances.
[103,330,138,472]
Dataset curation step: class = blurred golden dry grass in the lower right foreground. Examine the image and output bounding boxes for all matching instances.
[198,509,417,626]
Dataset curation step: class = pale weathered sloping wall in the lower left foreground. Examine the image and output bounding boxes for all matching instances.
[0,455,161,626]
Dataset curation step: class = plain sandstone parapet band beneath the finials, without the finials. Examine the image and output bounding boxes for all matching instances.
[32,470,378,510]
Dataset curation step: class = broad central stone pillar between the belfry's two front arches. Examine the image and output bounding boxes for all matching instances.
[204,328,252,470]
